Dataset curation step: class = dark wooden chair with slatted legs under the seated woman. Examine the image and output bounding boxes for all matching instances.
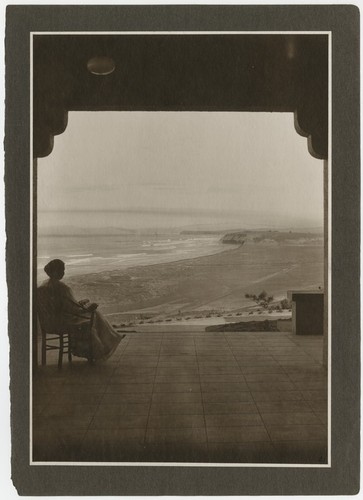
[37,286,94,369]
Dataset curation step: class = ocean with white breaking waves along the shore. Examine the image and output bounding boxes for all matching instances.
[37,233,226,282]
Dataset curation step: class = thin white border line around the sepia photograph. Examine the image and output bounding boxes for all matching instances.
[29,31,332,469]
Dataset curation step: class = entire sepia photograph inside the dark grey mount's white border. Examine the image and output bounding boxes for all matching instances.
[31,33,329,465]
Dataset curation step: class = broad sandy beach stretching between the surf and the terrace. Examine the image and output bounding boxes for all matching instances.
[65,240,323,324]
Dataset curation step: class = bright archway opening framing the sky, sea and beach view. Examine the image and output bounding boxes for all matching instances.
[38,112,324,330]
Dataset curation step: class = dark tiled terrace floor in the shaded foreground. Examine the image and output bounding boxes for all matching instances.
[33,331,327,464]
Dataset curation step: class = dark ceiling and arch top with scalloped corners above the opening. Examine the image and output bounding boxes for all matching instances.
[33,34,328,158]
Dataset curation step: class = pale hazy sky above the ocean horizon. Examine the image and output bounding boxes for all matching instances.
[38,112,323,229]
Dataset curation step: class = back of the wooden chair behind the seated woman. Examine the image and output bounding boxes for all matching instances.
[37,285,62,333]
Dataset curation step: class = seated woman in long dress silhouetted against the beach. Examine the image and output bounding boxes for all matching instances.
[39,259,125,360]
